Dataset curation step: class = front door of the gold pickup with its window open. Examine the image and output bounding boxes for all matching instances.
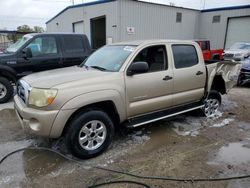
[126,45,173,117]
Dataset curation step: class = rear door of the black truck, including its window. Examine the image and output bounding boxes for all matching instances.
[61,35,87,67]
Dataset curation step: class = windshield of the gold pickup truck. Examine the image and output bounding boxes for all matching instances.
[81,46,135,72]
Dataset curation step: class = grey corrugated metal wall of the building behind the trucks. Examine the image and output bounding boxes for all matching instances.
[47,0,250,49]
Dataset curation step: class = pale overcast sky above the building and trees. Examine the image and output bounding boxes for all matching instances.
[0,0,250,30]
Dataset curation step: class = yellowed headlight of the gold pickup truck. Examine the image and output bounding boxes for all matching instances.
[29,88,57,107]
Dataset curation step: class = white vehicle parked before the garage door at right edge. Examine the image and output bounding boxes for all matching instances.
[224,42,250,60]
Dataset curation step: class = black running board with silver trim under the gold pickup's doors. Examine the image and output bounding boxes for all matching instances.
[124,103,204,128]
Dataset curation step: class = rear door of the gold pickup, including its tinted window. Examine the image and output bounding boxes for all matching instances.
[171,44,206,106]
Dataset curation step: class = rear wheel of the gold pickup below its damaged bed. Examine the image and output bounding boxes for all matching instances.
[202,91,221,117]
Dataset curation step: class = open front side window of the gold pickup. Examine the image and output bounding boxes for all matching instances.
[133,45,168,72]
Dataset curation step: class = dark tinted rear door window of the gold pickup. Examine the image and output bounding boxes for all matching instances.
[172,45,199,69]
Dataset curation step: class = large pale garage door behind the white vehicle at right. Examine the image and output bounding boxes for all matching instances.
[225,17,250,48]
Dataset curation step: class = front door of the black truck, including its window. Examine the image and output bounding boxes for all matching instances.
[17,35,62,76]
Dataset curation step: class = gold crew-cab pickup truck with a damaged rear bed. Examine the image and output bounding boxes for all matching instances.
[14,40,241,158]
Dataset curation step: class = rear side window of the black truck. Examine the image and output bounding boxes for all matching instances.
[63,36,84,53]
